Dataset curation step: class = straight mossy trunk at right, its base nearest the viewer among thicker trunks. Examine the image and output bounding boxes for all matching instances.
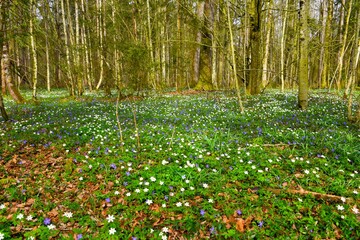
[298,0,310,110]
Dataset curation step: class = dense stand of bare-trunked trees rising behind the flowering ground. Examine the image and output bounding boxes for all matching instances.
[0,0,360,116]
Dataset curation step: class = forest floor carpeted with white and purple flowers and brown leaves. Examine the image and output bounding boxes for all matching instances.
[0,91,360,239]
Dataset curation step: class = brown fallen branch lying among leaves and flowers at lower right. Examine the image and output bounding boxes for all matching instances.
[266,186,359,203]
